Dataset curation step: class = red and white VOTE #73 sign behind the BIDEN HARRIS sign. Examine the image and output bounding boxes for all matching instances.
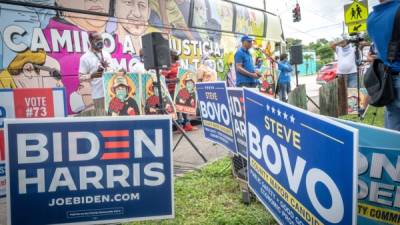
[0,88,67,198]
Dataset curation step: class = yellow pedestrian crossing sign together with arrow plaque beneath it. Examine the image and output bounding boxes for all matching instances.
[344,0,368,33]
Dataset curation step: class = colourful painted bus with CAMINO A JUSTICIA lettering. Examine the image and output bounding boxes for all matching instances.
[0,0,283,115]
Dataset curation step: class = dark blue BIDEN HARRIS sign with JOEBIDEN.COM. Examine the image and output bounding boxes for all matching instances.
[5,116,174,225]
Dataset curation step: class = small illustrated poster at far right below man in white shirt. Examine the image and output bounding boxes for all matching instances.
[347,88,369,115]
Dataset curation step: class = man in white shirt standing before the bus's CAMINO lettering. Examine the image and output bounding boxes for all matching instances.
[79,33,115,116]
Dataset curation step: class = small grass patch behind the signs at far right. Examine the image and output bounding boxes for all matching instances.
[341,106,384,127]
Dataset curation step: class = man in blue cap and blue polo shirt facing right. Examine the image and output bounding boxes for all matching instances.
[235,35,261,88]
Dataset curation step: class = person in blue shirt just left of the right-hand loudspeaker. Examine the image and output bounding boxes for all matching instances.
[277,53,293,102]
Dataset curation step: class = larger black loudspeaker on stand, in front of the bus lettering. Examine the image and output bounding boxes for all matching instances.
[142,32,171,70]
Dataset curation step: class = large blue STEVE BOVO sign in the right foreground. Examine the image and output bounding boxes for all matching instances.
[244,89,358,225]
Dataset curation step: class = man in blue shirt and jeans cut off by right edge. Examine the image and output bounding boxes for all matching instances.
[367,0,400,131]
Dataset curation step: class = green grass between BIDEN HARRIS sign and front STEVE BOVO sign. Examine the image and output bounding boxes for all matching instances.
[130,158,277,225]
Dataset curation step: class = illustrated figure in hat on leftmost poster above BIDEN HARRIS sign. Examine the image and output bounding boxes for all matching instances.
[107,72,140,116]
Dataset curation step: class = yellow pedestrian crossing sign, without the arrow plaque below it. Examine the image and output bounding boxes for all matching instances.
[344,0,368,25]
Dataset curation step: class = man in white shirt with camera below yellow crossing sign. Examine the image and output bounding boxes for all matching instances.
[332,40,358,88]
